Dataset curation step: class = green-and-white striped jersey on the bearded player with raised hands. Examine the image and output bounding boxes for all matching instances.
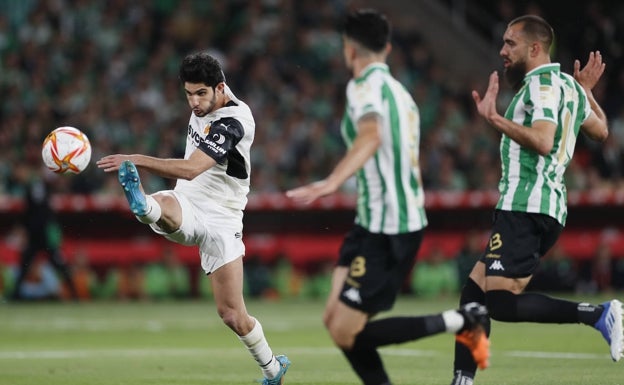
[496,63,591,225]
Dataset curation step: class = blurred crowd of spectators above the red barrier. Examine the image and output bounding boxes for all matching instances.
[0,0,624,195]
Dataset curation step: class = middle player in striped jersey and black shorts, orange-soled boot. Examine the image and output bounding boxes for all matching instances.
[287,10,489,385]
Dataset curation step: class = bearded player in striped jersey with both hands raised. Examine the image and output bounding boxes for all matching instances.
[452,15,624,385]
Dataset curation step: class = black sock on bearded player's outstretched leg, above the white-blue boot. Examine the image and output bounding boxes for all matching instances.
[485,290,602,325]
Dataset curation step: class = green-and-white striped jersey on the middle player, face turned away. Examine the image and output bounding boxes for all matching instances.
[341,63,427,234]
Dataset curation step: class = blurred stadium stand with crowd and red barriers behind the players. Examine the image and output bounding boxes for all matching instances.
[0,0,624,296]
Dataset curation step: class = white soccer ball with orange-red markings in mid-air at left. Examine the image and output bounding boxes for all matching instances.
[41,127,91,174]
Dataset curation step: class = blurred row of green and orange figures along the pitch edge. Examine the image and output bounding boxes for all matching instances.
[0,230,624,303]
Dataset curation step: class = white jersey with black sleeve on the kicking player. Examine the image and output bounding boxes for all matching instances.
[175,86,256,210]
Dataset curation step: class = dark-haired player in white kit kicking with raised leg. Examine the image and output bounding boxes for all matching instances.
[97,52,290,385]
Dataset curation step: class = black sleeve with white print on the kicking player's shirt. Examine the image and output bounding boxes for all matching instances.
[198,117,245,164]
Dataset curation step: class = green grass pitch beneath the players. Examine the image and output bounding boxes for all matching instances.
[0,297,624,385]
